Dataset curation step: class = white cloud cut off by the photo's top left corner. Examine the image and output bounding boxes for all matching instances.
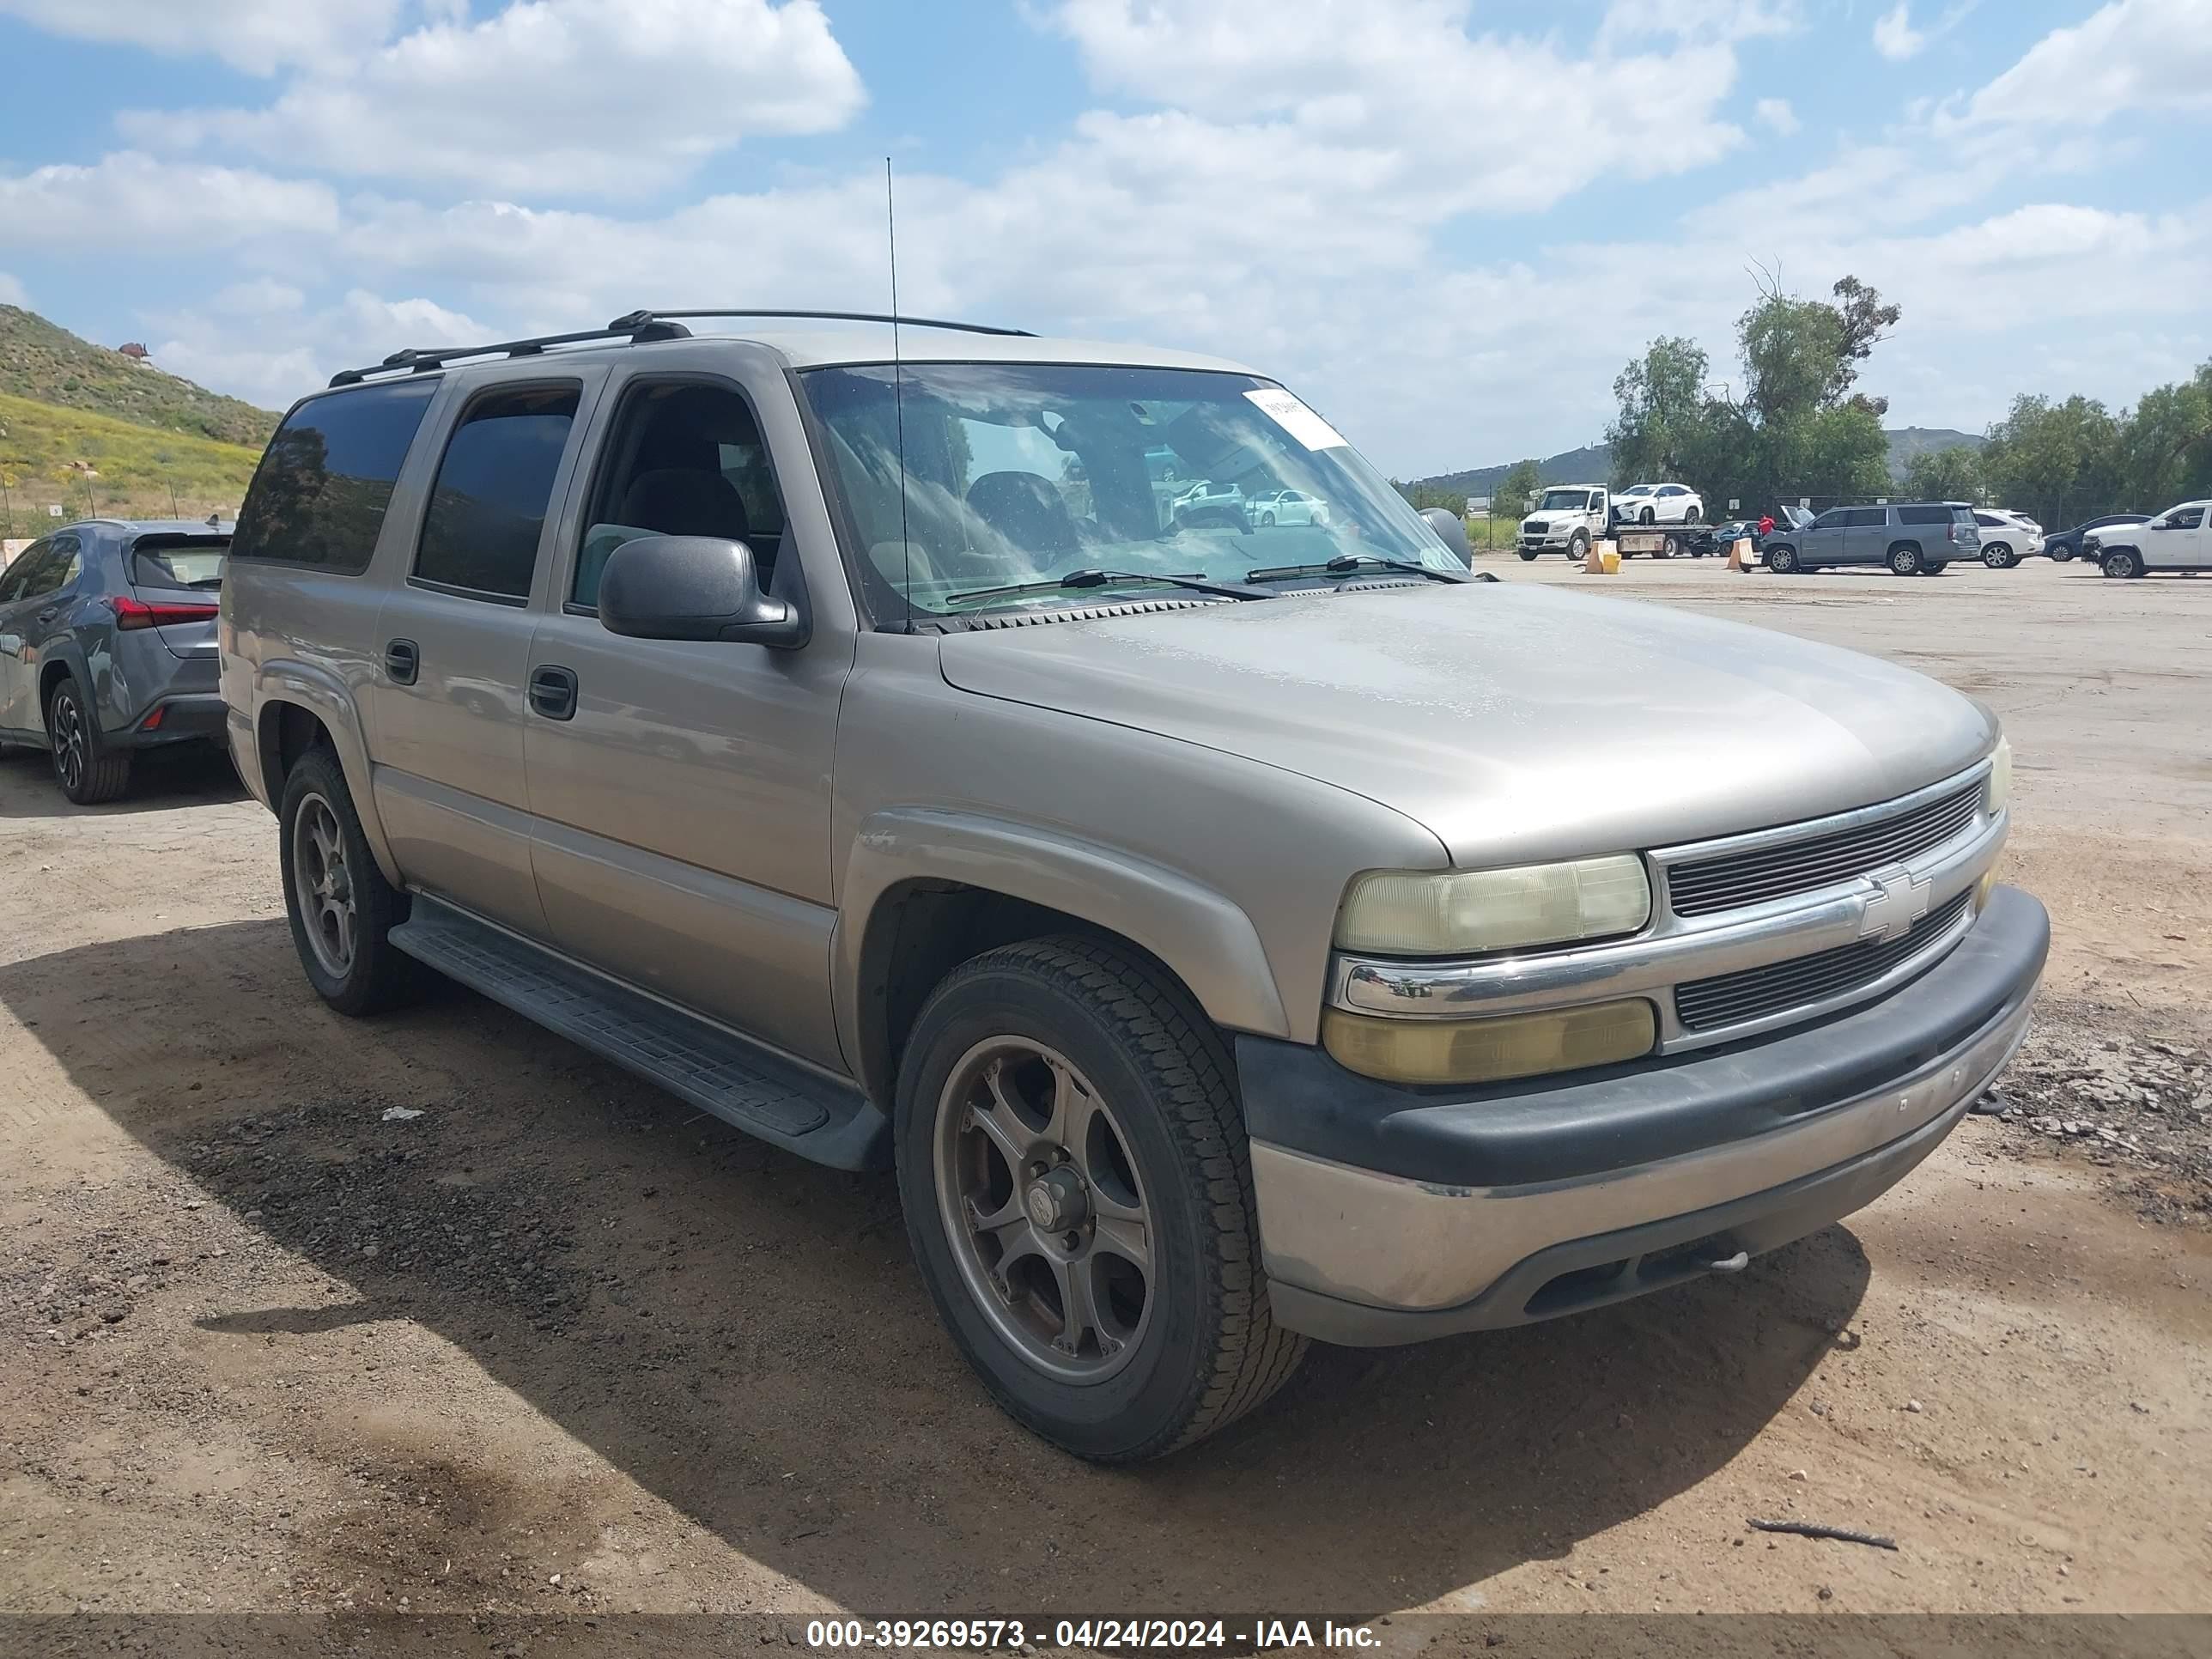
[0,0,400,76]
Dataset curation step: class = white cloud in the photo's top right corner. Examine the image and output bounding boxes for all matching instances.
[1964,0,2212,126]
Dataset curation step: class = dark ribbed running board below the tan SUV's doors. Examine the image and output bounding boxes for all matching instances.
[392,894,891,1170]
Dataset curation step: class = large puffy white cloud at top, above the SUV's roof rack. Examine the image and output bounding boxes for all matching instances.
[124,0,865,195]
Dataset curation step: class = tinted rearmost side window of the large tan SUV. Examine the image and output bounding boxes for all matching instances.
[230,380,438,575]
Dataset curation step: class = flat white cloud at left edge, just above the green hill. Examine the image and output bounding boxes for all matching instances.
[0,150,338,248]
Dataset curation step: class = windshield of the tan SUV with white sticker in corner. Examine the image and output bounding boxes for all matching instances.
[799,362,1467,617]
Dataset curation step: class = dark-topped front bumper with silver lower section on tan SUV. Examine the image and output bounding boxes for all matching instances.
[1239,890,2048,1347]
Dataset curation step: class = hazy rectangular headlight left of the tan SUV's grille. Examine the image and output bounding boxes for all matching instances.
[1336,854,1652,956]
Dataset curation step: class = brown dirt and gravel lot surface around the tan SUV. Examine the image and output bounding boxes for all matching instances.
[0,560,2212,1617]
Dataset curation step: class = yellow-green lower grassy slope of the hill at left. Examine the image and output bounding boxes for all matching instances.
[0,394,261,538]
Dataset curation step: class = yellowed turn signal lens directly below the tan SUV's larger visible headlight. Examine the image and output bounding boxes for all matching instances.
[1321,998,1659,1084]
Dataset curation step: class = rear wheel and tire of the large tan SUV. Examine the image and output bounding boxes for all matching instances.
[276,748,422,1018]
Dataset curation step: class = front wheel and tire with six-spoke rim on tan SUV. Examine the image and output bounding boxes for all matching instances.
[894,938,1305,1462]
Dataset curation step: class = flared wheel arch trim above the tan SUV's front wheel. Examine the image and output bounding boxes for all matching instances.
[832,807,1290,1097]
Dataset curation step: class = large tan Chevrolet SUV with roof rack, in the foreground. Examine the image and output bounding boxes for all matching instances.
[223,312,2048,1460]
